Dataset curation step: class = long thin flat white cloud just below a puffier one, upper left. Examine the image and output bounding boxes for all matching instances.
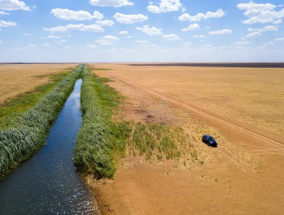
[43,24,104,33]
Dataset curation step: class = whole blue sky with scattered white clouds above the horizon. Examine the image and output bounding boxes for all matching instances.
[0,0,284,62]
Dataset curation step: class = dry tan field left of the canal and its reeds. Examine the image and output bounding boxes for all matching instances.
[0,64,76,103]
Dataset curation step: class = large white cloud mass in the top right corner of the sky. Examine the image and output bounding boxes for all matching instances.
[237,1,284,24]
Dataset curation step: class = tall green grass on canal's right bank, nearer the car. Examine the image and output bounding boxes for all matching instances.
[74,69,129,178]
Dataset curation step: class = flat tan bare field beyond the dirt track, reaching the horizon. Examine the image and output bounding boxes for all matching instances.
[90,64,284,135]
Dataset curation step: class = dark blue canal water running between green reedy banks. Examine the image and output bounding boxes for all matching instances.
[0,79,98,215]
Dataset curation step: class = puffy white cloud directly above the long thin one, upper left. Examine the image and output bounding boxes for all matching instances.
[51,8,104,20]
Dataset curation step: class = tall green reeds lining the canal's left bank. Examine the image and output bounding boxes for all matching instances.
[0,65,85,180]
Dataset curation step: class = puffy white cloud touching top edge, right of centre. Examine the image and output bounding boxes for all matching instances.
[148,0,185,13]
